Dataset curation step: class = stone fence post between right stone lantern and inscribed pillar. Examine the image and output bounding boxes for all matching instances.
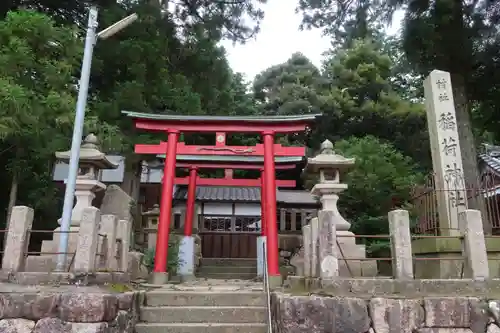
[388,209,413,280]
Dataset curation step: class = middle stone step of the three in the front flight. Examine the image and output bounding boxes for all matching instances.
[140,306,266,323]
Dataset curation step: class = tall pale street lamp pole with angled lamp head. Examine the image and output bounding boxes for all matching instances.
[56,6,137,271]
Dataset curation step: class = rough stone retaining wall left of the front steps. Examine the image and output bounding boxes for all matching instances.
[0,287,140,333]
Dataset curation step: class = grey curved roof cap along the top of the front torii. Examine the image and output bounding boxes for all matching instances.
[122,110,322,123]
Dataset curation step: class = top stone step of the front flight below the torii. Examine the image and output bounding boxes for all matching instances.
[145,290,266,307]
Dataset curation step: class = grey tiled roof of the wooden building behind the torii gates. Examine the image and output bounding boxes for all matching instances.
[174,186,317,204]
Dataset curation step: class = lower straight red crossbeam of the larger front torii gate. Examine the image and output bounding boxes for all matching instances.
[135,141,306,157]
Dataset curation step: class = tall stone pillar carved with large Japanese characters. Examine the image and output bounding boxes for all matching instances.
[424,70,467,235]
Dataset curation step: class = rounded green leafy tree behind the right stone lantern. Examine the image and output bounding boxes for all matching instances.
[335,136,422,235]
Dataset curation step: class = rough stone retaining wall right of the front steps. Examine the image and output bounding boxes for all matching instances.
[271,293,500,333]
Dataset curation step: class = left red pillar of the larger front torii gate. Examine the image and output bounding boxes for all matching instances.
[154,131,179,273]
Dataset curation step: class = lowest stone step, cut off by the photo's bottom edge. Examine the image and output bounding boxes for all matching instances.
[135,323,267,333]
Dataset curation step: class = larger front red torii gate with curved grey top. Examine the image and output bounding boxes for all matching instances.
[123,111,318,283]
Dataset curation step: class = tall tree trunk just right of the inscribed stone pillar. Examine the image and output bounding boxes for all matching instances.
[451,74,491,234]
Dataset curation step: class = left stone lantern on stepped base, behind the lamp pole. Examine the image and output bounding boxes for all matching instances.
[26,134,118,271]
